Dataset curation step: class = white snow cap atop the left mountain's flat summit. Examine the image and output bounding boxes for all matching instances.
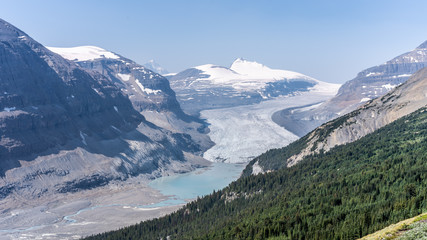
[46,46,120,62]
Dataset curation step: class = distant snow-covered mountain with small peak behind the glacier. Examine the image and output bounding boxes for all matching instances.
[169,58,340,114]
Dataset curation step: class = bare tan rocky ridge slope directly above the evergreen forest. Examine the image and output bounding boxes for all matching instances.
[247,65,427,174]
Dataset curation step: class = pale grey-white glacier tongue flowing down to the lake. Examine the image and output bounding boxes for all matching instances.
[201,92,338,163]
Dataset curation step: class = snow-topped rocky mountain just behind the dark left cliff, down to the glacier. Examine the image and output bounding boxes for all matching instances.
[48,46,212,155]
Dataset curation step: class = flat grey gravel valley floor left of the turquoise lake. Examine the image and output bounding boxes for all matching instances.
[0,178,181,240]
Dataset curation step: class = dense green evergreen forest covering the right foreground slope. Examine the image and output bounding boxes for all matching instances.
[84,108,427,239]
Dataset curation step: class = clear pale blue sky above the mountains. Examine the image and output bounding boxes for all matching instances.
[0,0,427,83]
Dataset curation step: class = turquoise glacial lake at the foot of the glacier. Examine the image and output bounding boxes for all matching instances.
[149,163,246,207]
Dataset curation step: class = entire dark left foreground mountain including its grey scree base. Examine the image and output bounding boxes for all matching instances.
[0,19,209,199]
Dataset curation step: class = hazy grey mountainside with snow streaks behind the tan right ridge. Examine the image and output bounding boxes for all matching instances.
[273,41,427,136]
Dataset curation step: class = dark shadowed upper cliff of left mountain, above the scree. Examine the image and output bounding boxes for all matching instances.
[0,21,139,165]
